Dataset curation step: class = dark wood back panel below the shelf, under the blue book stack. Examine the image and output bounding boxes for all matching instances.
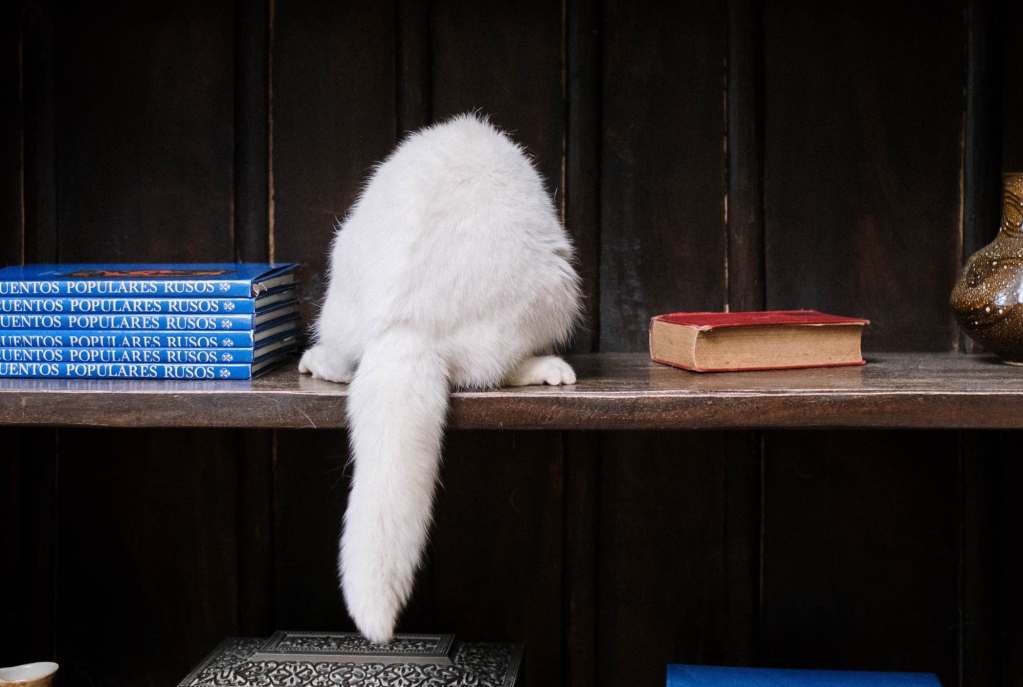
[57,430,243,687]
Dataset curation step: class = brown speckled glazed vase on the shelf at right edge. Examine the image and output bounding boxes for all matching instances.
[951,173,1023,365]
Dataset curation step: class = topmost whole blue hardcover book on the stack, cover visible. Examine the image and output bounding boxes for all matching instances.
[0,263,297,299]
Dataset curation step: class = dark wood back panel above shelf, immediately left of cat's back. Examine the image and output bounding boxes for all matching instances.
[271,0,396,324]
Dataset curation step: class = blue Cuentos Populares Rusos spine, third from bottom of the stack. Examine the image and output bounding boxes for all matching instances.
[0,329,256,349]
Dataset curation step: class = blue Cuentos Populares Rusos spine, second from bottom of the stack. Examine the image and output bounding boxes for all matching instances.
[0,348,253,365]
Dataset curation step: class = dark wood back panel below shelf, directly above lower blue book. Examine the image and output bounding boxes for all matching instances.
[760,432,962,685]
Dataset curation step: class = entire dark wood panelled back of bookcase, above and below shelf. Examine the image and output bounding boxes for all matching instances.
[0,0,1023,687]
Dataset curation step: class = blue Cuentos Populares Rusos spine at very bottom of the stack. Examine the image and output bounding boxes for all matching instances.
[0,362,252,380]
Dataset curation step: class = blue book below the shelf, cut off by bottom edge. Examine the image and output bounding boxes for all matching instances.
[667,665,941,687]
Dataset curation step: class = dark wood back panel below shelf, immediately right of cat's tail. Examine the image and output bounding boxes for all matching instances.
[423,432,566,687]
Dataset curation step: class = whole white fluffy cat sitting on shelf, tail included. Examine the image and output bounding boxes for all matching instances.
[299,115,579,641]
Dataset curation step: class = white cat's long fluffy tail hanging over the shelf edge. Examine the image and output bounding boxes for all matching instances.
[339,329,449,642]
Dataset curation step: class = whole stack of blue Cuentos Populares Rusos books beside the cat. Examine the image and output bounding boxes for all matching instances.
[0,263,299,379]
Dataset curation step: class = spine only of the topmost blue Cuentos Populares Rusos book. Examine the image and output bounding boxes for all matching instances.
[0,279,253,299]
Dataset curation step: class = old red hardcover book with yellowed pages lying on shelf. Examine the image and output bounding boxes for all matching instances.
[650,310,870,372]
